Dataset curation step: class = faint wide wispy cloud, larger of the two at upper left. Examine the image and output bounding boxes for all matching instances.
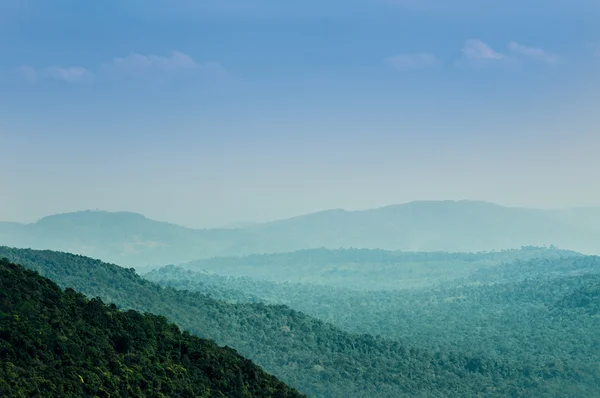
[107,51,226,77]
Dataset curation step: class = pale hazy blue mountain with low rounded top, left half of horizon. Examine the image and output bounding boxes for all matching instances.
[0,211,252,267]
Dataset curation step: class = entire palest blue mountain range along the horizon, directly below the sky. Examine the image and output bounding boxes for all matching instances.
[0,201,600,267]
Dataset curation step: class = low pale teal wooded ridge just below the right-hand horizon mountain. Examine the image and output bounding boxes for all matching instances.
[181,246,582,290]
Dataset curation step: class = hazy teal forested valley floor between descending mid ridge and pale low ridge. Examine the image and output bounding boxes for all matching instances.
[146,256,600,393]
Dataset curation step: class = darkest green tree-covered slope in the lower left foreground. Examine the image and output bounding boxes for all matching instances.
[0,259,302,398]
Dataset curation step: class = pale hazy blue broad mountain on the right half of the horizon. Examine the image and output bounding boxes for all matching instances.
[248,201,600,252]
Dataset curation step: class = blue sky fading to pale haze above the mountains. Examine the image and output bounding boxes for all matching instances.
[0,0,600,227]
